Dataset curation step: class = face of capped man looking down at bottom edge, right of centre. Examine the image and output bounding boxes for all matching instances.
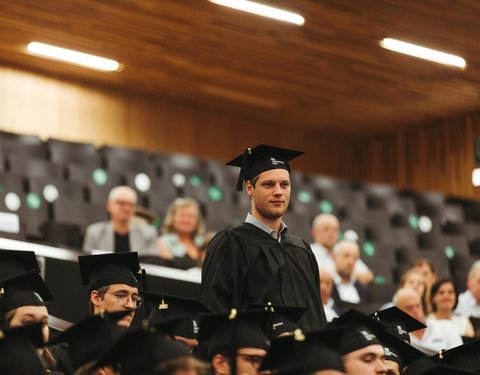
[343,345,387,375]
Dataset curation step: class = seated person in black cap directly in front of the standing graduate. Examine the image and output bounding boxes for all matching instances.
[199,309,269,375]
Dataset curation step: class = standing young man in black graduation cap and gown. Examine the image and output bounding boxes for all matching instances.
[201,145,325,331]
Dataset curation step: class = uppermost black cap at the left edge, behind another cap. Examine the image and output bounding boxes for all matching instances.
[0,249,40,280]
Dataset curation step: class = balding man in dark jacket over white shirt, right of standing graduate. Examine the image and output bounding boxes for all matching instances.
[332,240,371,303]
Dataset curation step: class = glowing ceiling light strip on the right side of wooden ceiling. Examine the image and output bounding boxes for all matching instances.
[380,38,467,69]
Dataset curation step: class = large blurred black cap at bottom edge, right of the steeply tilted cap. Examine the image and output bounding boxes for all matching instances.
[97,328,190,374]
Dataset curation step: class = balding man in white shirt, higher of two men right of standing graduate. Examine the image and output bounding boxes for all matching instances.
[310,214,374,284]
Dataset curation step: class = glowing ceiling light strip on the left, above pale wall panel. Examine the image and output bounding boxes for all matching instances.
[27,42,120,71]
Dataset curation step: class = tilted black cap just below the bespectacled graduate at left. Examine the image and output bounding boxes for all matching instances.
[47,310,132,370]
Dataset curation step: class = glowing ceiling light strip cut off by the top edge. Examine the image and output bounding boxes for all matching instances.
[210,0,305,26]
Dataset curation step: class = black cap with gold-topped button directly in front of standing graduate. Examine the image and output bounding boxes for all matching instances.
[198,309,269,359]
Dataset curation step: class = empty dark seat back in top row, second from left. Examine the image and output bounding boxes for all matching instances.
[46,138,102,167]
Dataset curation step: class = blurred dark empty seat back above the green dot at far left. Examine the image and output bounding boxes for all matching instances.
[7,154,65,179]
